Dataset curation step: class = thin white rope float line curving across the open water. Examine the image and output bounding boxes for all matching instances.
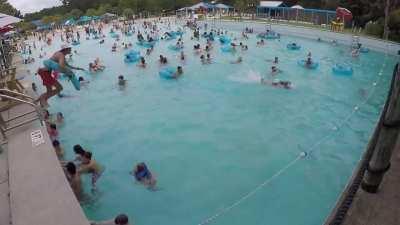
[198,52,387,225]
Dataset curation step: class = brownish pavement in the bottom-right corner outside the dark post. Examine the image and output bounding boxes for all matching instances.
[343,139,400,225]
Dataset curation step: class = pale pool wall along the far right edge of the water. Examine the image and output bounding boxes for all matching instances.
[201,20,400,55]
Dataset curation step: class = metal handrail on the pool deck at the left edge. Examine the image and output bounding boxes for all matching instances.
[0,89,44,139]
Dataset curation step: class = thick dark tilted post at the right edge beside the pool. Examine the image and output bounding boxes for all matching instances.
[361,64,400,193]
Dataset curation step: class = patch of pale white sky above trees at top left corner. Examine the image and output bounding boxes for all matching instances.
[8,0,61,14]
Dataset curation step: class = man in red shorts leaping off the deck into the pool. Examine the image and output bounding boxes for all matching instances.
[38,45,84,107]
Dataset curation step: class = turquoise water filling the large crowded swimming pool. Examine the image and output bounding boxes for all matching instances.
[25,21,395,225]
